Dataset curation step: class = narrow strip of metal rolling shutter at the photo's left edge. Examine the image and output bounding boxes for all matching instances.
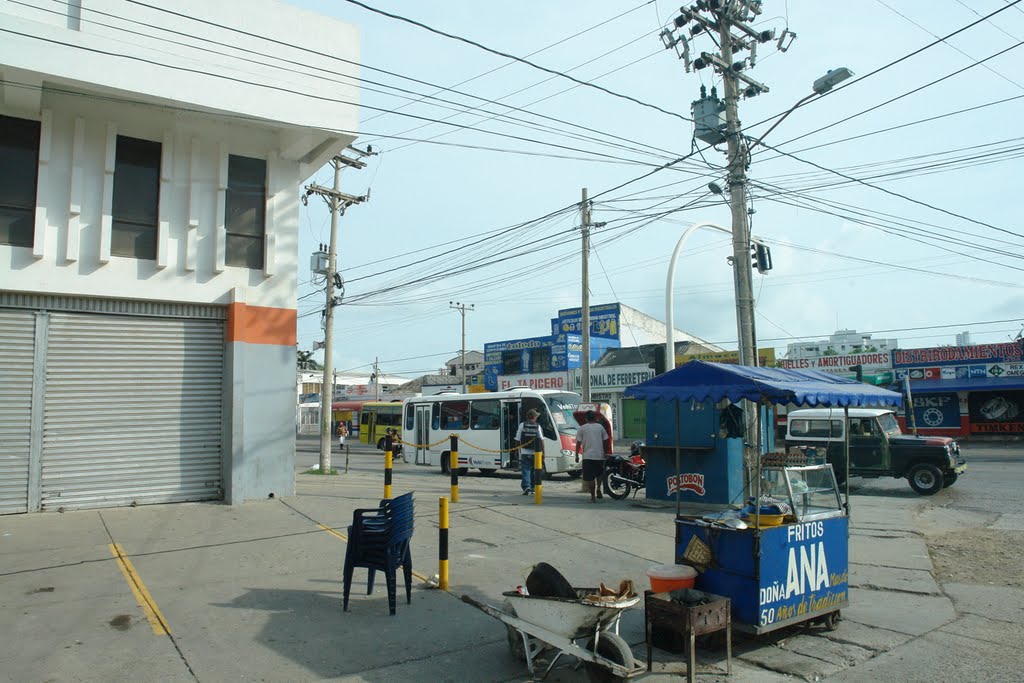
[0,310,36,514]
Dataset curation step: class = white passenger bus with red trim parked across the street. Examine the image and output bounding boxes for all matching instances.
[401,387,583,479]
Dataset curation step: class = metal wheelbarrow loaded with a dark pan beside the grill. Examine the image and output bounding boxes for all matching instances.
[462,587,646,681]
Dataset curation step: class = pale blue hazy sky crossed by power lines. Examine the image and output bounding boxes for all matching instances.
[291,0,1024,377]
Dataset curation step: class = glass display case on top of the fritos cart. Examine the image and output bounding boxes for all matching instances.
[761,465,846,522]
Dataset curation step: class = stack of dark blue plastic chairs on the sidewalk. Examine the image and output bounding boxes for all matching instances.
[343,493,415,614]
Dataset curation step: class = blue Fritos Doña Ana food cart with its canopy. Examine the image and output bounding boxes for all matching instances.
[626,360,902,634]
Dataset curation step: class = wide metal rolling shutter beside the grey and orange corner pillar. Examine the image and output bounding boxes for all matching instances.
[42,312,224,510]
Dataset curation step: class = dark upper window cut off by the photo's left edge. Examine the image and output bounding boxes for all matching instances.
[0,116,39,247]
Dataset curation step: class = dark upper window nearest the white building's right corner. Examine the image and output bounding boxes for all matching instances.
[224,155,266,269]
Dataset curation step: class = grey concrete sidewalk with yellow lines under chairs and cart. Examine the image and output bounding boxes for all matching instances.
[0,451,1007,683]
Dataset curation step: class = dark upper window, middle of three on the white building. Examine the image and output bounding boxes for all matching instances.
[111,135,161,261]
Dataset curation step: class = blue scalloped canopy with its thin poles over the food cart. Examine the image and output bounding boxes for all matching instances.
[625,360,903,514]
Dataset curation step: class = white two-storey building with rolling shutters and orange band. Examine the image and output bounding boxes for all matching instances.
[0,0,358,513]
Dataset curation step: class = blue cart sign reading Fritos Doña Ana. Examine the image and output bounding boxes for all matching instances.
[758,519,849,627]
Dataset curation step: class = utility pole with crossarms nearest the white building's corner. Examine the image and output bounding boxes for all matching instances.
[302,147,373,474]
